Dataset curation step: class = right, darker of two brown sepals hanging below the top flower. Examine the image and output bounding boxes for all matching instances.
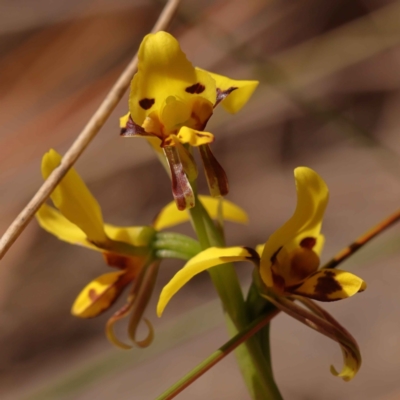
[199,144,229,197]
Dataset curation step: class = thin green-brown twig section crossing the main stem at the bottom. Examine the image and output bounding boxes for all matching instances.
[156,309,278,400]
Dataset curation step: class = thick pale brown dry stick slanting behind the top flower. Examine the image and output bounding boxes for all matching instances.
[0,0,180,259]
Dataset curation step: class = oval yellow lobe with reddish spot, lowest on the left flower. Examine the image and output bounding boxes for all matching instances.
[71,271,130,318]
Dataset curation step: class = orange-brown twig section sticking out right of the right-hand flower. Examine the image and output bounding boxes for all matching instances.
[322,210,400,268]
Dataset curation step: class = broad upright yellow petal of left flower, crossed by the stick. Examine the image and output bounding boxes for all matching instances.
[42,149,107,243]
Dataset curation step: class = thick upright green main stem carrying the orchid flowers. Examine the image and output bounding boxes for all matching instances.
[189,188,282,400]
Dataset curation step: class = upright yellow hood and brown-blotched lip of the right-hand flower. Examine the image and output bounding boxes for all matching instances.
[260,167,366,301]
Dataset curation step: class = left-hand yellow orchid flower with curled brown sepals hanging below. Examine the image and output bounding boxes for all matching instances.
[36,149,247,348]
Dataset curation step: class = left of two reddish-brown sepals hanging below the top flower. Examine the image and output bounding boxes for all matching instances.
[163,146,195,210]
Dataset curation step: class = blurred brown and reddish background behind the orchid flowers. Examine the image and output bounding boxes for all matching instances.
[0,0,400,400]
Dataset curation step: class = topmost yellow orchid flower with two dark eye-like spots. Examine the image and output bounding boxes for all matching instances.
[120,32,258,210]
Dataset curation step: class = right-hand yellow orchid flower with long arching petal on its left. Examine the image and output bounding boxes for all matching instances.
[157,167,366,380]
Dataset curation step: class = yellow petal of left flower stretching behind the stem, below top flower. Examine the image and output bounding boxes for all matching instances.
[153,196,248,231]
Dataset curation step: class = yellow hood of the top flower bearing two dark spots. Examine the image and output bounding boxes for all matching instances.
[129,32,216,125]
